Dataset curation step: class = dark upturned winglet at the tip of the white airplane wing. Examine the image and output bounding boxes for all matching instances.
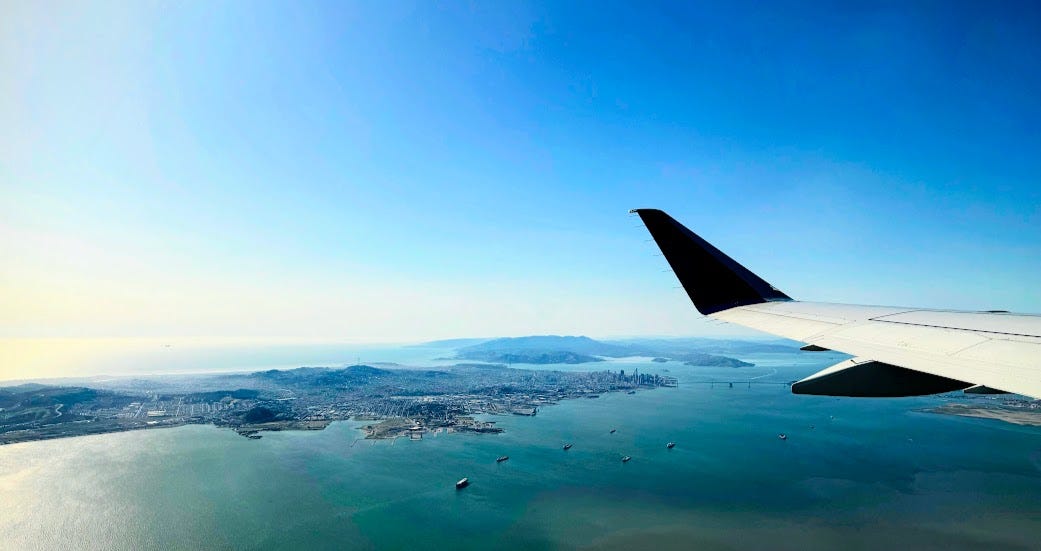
[630,208,791,316]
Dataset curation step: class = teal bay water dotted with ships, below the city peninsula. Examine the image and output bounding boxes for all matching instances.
[0,354,1041,550]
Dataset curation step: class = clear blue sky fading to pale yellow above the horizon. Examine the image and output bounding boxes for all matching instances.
[0,2,1041,341]
